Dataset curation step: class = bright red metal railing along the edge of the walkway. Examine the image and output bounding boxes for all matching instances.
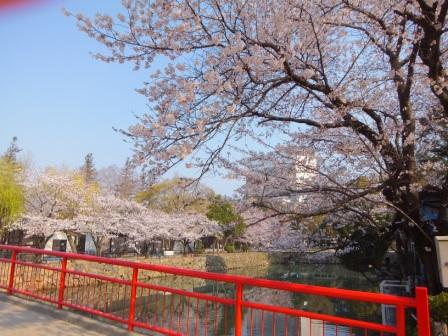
[0,245,430,336]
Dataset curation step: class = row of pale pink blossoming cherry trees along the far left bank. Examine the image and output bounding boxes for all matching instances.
[13,169,221,255]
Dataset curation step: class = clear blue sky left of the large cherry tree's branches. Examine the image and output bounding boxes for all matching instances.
[0,0,242,195]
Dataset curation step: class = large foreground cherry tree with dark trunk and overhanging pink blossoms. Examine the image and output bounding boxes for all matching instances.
[68,0,448,288]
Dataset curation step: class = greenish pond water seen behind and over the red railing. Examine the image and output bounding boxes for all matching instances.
[126,264,381,336]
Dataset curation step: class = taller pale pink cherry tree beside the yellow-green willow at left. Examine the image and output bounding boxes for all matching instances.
[15,168,130,252]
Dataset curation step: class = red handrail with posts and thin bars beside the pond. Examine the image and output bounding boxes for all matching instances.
[0,245,430,336]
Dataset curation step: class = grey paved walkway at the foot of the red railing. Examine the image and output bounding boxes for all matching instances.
[0,293,136,336]
